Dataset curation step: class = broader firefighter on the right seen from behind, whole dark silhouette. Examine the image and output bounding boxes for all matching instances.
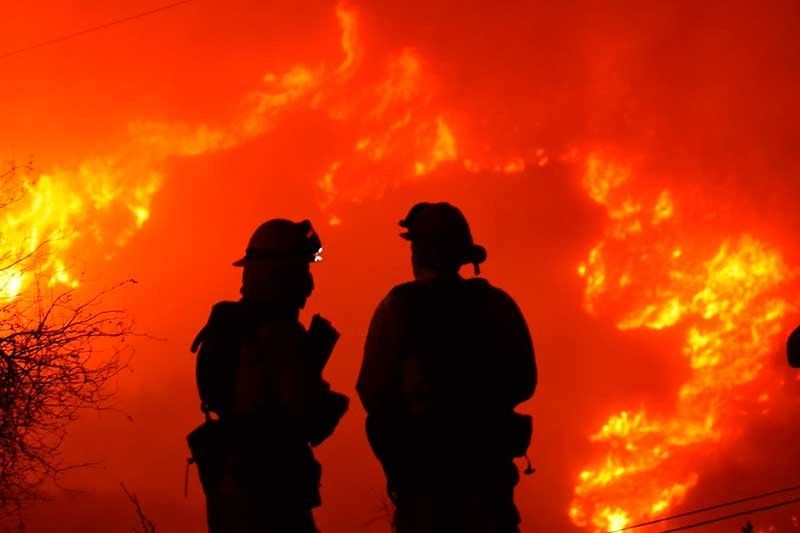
[357,203,537,533]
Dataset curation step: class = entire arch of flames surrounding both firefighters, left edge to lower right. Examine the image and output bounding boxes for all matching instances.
[10,4,791,530]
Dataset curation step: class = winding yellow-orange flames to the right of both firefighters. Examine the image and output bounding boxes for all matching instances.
[569,155,792,531]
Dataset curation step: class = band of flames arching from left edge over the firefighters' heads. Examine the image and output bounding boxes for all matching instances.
[0,3,548,298]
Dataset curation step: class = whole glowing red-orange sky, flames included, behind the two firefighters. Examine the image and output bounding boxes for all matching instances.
[0,0,800,533]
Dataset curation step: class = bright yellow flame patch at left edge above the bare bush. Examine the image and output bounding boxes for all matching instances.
[0,162,160,301]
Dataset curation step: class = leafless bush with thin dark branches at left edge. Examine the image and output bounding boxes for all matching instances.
[0,162,131,517]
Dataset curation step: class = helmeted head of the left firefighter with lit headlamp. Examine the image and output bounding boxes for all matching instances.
[234,218,322,309]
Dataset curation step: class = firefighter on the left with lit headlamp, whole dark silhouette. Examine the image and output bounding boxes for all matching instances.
[188,219,348,533]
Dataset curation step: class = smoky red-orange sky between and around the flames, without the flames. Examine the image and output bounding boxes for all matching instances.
[0,0,800,533]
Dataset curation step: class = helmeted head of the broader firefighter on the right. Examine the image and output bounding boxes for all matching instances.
[400,202,486,277]
